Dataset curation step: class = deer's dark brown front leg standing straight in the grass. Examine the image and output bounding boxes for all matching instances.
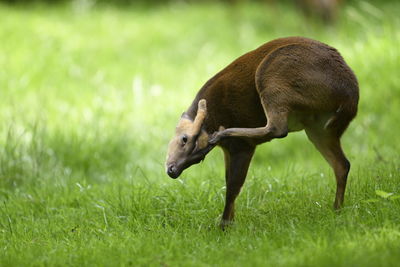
[220,141,255,229]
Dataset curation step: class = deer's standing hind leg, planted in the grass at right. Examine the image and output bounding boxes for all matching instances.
[305,127,350,209]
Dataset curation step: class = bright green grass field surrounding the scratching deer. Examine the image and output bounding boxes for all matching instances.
[0,2,400,266]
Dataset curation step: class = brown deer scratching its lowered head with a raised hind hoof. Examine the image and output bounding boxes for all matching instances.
[165,37,359,229]
